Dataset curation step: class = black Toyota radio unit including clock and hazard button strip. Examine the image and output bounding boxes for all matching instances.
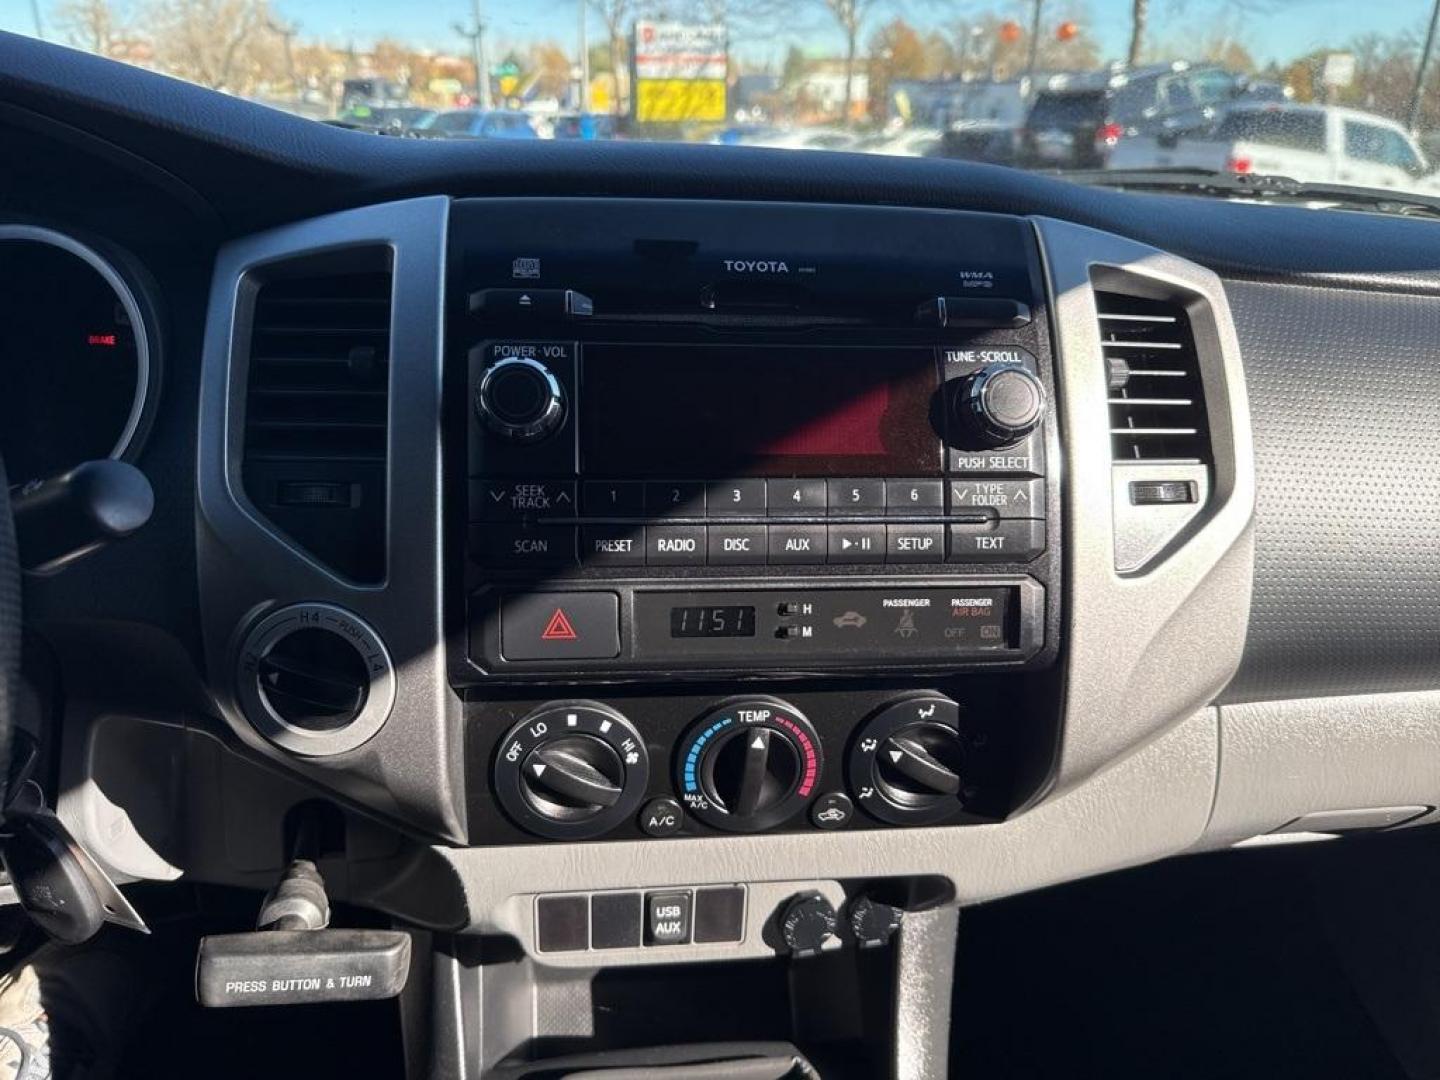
[451,203,1058,678]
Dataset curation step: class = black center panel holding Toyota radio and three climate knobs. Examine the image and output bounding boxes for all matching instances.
[448,200,1061,844]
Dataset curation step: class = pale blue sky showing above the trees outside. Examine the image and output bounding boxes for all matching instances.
[0,0,1430,66]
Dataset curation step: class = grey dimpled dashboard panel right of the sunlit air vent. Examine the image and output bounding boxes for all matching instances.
[1224,282,1440,701]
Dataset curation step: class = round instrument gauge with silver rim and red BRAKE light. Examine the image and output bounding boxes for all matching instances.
[0,225,157,487]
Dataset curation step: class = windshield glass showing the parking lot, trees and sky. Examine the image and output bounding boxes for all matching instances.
[11,0,1440,194]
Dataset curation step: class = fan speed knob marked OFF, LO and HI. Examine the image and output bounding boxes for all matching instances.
[494,701,649,840]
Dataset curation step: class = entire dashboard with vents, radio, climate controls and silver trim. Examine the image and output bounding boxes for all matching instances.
[0,29,1440,1077]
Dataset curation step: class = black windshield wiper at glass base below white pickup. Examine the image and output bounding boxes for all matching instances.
[1050,167,1440,217]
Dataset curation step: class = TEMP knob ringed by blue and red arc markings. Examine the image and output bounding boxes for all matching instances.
[675,698,822,832]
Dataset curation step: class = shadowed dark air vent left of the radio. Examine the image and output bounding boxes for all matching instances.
[243,248,392,583]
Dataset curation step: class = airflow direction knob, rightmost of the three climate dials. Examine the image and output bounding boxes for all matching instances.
[850,694,968,825]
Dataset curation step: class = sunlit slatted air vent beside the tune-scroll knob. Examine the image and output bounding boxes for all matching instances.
[1094,289,1211,465]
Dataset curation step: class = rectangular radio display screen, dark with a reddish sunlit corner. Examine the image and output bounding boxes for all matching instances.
[580,344,942,480]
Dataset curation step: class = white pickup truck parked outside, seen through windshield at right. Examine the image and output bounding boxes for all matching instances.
[1109,105,1440,194]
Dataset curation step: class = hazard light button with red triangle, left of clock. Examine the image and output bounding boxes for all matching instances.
[500,592,621,660]
